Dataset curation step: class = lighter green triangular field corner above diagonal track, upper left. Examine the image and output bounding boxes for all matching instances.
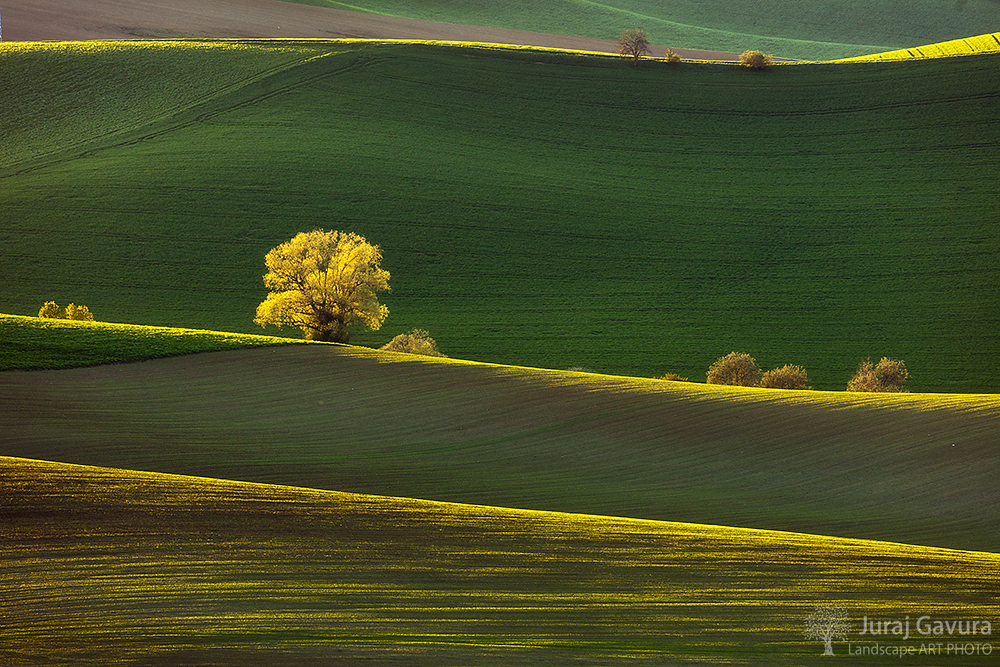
[0,41,332,167]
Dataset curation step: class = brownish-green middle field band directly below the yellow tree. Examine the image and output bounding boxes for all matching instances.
[0,345,1000,551]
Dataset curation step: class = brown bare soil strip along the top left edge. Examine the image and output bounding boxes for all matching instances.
[3,0,736,60]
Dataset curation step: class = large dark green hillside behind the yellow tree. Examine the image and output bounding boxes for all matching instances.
[0,42,1000,392]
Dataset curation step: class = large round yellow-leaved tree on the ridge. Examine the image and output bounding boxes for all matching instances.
[254,229,389,343]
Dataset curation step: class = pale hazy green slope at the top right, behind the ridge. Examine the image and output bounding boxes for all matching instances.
[292,0,997,60]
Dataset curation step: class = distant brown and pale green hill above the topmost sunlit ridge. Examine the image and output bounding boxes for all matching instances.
[11,0,1000,60]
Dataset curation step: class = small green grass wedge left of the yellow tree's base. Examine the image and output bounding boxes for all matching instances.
[0,314,299,371]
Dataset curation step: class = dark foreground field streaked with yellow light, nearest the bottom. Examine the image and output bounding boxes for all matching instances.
[0,458,1000,667]
